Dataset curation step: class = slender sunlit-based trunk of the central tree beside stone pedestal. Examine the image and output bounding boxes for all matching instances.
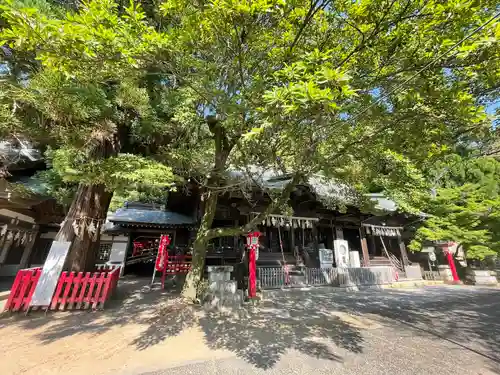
[182,191,217,301]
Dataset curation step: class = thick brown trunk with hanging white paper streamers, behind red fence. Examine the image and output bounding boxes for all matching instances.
[55,184,113,272]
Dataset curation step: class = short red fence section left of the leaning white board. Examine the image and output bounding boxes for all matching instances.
[5,268,42,311]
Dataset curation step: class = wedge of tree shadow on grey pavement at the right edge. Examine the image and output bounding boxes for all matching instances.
[316,286,500,363]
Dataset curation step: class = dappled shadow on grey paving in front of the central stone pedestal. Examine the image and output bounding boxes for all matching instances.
[199,296,363,369]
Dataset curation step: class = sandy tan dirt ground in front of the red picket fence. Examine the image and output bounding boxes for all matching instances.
[0,280,232,375]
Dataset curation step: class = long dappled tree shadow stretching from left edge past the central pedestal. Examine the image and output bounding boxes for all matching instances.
[0,280,363,369]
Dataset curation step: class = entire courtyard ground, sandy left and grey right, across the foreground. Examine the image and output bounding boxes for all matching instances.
[0,283,500,375]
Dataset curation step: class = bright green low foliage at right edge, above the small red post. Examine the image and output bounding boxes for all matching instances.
[410,156,500,259]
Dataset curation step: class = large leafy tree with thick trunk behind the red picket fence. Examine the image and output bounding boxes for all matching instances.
[0,1,173,271]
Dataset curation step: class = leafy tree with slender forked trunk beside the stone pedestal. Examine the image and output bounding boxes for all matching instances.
[150,0,499,297]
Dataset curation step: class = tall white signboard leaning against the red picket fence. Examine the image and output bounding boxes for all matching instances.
[30,241,71,306]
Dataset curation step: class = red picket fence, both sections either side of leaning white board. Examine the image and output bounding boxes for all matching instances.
[5,267,120,311]
